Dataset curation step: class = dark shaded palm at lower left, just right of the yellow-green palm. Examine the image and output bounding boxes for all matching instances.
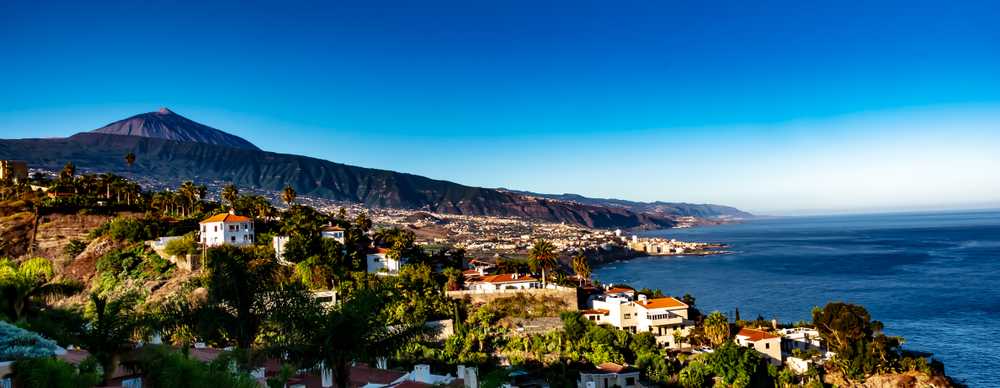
[80,293,156,386]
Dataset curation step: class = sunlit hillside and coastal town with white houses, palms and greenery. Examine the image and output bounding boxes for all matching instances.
[0,159,958,388]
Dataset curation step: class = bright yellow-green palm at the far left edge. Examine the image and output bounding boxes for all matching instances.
[0,257,83,320]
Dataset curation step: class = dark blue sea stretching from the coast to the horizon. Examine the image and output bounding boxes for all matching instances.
[594,211,1000,387]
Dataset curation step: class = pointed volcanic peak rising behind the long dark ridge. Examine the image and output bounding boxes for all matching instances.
[90,108,260,151]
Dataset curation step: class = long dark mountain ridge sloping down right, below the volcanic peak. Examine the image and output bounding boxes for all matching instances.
[0,133,677,229]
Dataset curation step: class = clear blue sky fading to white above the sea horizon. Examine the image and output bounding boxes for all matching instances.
[0,0,1000,214]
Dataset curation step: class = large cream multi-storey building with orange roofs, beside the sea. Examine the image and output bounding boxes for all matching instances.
[584,288,694,348]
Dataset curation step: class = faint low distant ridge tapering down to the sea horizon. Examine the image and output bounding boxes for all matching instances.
[512,190,757,219]
